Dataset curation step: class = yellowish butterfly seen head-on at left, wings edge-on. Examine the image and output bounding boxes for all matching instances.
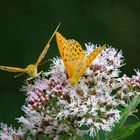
[0,23,60,80]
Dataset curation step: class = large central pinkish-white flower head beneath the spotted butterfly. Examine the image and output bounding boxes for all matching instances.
[19,44,131,138]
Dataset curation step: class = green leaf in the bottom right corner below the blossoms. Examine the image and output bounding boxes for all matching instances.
[109,122,140,140]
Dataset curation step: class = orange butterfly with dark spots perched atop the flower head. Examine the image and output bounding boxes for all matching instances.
[56,32,105,85]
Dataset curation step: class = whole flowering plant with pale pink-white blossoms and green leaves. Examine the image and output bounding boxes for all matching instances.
[0,43,140,140]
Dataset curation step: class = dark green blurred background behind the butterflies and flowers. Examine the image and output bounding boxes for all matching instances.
[0,0,140,140]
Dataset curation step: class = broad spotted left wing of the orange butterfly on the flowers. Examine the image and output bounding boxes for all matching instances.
[56,32,85,78]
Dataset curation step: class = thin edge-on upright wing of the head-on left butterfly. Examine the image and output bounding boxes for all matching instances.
[35,23,60,66]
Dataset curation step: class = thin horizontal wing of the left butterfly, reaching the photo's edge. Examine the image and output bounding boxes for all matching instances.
[0,66,27,73]
